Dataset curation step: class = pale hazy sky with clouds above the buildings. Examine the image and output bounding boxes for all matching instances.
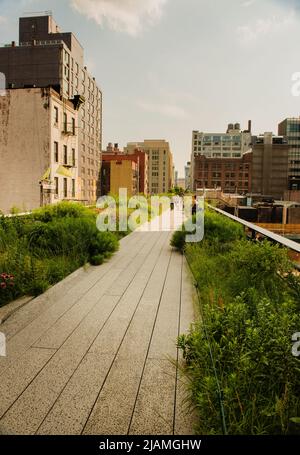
[0,0,300,176]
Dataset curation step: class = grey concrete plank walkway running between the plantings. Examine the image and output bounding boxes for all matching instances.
[0,212,194,435]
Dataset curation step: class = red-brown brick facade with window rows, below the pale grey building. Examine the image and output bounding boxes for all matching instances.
[193,152,252,194]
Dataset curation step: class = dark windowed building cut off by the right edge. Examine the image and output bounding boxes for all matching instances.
[278,117,300,191]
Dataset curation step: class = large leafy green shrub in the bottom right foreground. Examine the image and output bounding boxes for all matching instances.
[179,297,300,434]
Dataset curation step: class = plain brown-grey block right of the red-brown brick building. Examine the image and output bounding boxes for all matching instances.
[252,133,289,199]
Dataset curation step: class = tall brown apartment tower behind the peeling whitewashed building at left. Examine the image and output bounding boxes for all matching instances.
[0,15,102,203]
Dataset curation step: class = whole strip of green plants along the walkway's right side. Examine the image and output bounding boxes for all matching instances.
[172,211,300,435]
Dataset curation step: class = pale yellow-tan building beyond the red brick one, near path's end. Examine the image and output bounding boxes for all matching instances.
[124,140,174,194]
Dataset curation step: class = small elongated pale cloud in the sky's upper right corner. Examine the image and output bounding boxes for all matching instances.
[237,11,295,44]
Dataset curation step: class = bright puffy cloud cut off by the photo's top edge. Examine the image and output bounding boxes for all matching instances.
[70,0,168,36]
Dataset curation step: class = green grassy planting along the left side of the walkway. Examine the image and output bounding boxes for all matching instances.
[0,203,118,306]
